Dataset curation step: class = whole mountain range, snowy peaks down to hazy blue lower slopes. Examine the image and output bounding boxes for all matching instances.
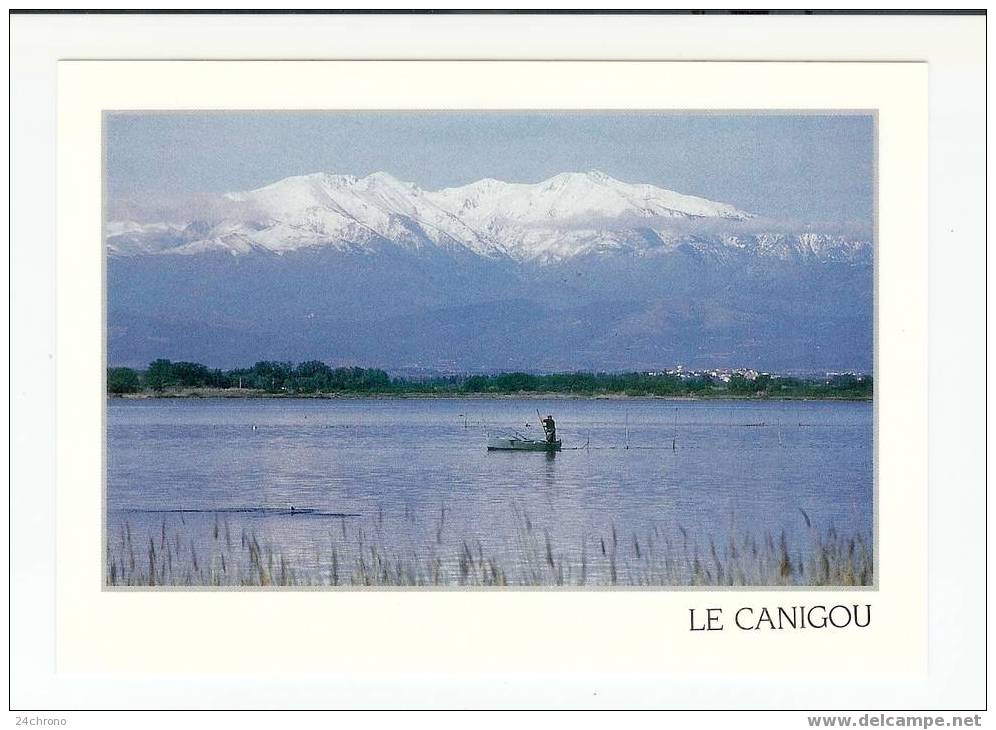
[106,172,874,371]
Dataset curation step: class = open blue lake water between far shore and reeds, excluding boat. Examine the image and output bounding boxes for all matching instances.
[107,399,873,581]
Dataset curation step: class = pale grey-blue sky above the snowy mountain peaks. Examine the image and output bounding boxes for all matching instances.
[105,111,875,224]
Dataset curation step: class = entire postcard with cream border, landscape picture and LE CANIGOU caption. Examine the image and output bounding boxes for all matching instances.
[52,62,926,673]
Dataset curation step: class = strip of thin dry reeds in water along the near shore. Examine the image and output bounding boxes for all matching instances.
[104,508,875,588]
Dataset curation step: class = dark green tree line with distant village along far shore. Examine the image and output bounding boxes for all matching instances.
[107,359,874,400]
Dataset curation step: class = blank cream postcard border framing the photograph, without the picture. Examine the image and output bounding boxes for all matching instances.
[56,61,927,675]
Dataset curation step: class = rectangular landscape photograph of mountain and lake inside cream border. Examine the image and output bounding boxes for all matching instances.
[102,110,877,590]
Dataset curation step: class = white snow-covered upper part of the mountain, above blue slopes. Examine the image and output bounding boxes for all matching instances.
[107,171,868,263]
